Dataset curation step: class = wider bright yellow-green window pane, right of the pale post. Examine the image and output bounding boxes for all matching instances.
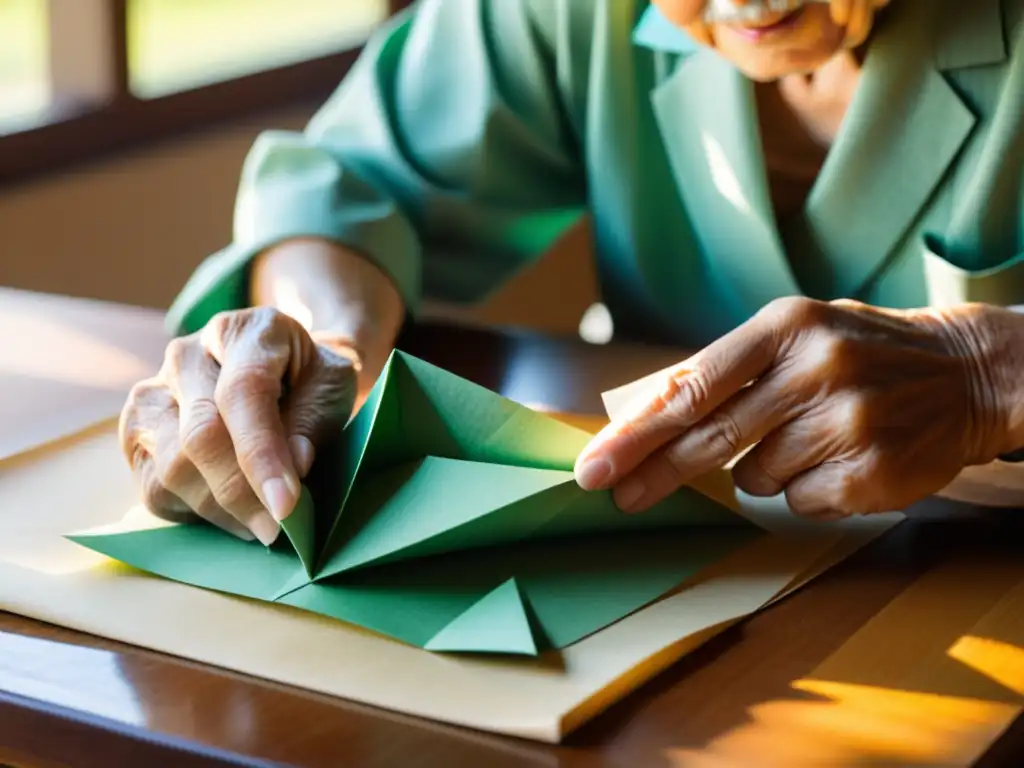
[128,0,388,97]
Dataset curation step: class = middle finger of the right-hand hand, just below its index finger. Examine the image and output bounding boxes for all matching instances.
[613,374,803,513]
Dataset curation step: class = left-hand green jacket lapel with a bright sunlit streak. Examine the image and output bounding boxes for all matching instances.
[651,50,800,312]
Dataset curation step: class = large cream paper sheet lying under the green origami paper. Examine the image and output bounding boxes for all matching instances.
[0,423,897,742]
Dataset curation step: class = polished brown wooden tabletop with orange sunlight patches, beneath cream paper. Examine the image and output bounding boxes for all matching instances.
[0,295,1024,768]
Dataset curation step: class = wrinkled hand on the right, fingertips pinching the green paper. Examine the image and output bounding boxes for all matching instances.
[577,299,1021,518]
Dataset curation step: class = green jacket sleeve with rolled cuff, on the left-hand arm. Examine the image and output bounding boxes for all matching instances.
[168,0,586,333]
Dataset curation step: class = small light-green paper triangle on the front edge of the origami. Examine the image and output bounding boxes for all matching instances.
[423,579,538,656]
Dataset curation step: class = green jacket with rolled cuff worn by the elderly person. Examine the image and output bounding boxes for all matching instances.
[169,0,1024,346]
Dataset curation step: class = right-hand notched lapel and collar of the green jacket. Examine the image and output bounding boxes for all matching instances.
[785,0,1006,299]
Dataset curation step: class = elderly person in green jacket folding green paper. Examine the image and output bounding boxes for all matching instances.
[122,0,1024,543]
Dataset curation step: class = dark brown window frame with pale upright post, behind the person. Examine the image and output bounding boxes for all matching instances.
[0,0,415,188]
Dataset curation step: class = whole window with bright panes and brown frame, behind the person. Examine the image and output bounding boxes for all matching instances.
[0,0,411,185]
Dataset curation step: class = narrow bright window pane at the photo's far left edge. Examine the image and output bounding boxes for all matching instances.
[0,0,50,133]
